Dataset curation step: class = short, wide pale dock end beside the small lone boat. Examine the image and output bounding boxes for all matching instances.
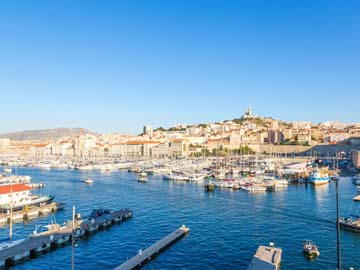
[247,244,282,270]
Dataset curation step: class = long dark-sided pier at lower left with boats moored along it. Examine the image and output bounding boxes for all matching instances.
[0,209,133,269]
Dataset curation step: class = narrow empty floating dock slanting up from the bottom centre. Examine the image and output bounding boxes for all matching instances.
[115,225,190,270]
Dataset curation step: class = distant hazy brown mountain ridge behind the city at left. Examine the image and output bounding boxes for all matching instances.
[0,128,95,141]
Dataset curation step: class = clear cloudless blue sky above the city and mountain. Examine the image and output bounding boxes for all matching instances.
[0,0,360,133]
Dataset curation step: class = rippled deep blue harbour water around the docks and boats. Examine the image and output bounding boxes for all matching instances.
[0,168,360,270]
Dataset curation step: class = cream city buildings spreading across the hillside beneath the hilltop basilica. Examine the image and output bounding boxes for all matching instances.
[0,108,360,161]
